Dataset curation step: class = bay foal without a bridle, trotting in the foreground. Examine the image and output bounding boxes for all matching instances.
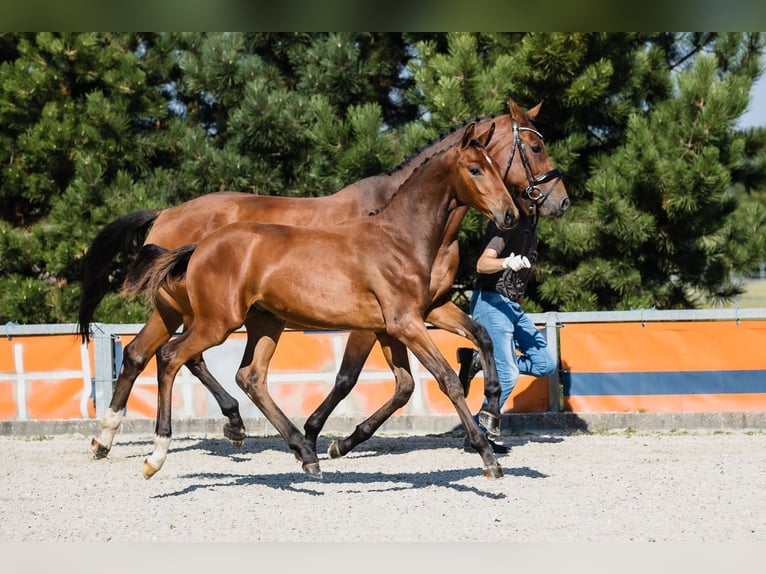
[125,124,519,478]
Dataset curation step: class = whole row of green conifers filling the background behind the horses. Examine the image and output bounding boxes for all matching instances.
[0,32,766,323]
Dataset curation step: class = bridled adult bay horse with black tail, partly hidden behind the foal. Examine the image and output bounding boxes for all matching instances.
[78,100,569,458]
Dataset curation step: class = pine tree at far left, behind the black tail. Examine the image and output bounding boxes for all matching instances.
[0,33,171,322]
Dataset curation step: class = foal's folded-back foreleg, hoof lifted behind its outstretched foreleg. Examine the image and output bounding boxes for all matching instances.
[327,334,415,458]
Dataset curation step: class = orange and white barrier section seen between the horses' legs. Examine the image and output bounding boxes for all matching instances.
[111,329,548,424]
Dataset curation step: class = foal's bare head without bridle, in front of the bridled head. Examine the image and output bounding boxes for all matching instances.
[456,123,519,229]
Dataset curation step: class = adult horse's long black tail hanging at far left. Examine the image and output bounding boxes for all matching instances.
[77,209,159,343]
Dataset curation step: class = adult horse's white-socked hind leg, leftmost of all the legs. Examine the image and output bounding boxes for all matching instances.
[90,309,181,458]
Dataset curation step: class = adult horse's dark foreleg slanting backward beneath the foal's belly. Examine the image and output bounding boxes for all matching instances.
[303,331,375,452]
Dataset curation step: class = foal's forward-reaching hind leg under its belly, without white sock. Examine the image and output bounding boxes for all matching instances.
[236,313,322,478]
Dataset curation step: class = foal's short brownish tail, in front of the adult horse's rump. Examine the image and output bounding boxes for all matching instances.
[122,243,196,300]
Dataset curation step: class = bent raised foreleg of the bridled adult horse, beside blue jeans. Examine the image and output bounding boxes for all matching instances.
[426,301,501,435]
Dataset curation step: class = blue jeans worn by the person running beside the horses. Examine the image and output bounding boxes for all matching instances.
[471,291,557,409]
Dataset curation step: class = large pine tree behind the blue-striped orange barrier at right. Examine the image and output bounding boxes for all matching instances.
[538,35,766,310]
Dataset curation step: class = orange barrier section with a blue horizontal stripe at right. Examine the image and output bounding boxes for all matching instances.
[559,321,766,412]
